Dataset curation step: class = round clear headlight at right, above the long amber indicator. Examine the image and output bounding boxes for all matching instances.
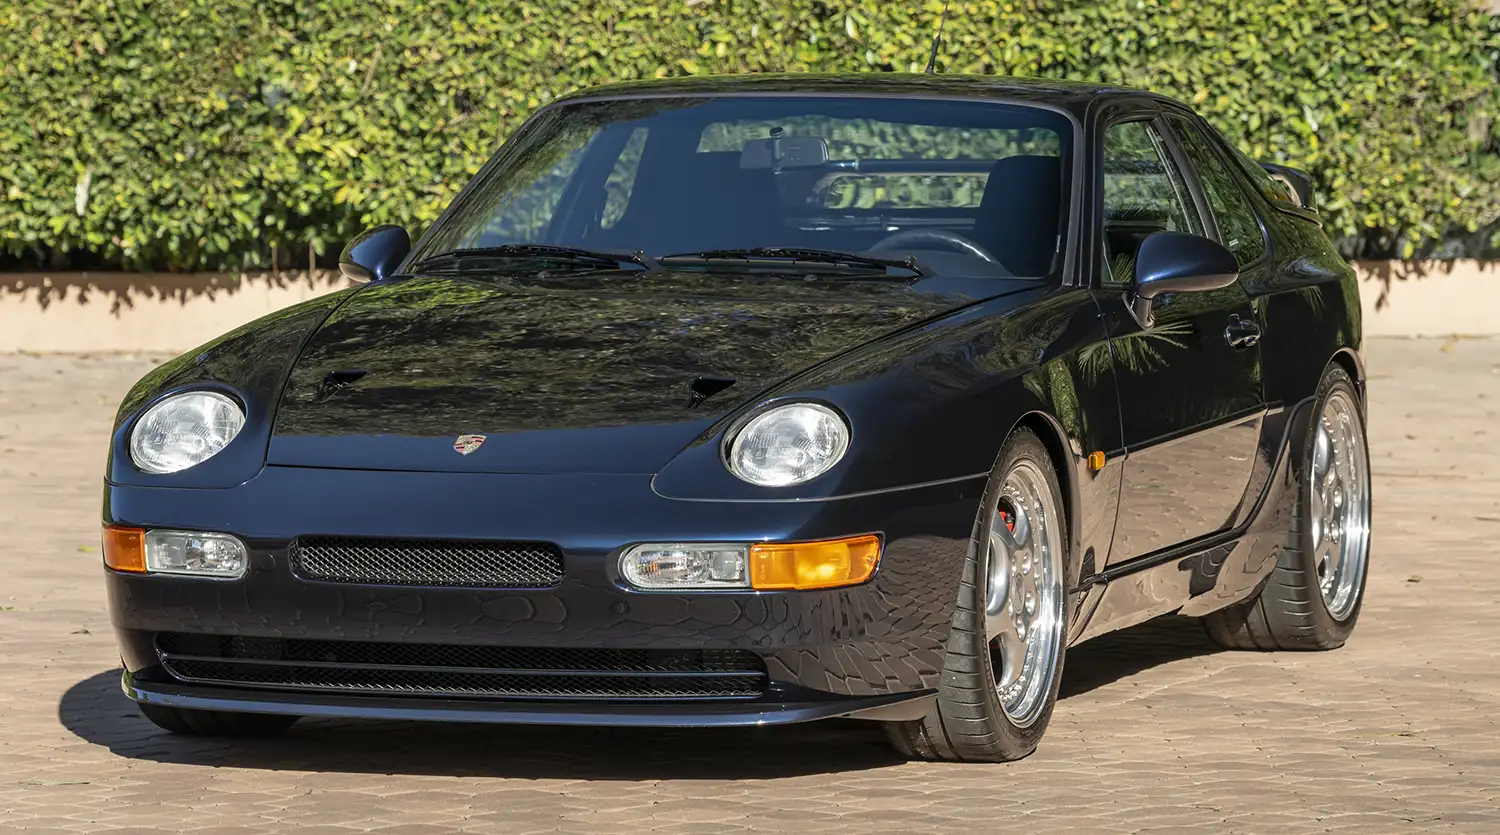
[729,403,849,487]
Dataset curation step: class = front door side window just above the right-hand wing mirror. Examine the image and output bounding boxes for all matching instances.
[1104,120,1203,285]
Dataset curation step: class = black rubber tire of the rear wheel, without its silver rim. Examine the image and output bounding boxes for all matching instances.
[1203,366,1370,651]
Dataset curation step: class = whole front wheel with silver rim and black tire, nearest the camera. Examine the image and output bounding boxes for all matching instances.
[887,429,1077,762]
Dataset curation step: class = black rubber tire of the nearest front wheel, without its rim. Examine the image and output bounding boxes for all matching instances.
[885,429,1079,763]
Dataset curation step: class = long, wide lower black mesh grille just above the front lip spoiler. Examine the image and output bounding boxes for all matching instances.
[156,633,767,699]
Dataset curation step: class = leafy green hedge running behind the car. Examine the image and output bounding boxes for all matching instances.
[0,0,1500,268]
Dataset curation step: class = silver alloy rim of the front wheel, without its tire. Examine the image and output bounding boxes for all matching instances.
[984,459,1064,727]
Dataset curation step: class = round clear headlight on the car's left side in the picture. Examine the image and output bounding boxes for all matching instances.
[131,391,245,472]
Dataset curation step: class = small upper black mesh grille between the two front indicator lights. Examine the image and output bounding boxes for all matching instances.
[291,537,563,589]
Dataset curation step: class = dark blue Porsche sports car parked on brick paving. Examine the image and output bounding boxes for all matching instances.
[104,75,1371,762]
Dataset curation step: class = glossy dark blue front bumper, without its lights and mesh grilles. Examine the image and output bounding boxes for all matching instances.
[104,466,983,726]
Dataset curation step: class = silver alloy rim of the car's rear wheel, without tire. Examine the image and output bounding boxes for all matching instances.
[1308,388,1370,621]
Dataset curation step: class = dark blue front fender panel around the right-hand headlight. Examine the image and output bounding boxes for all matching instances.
[654,288,1119,501]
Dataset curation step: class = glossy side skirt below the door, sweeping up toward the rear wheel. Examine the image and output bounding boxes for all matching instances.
[1073,400,1311,643]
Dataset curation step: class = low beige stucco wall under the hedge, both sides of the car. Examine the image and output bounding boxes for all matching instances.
[0,261,1500,354]
